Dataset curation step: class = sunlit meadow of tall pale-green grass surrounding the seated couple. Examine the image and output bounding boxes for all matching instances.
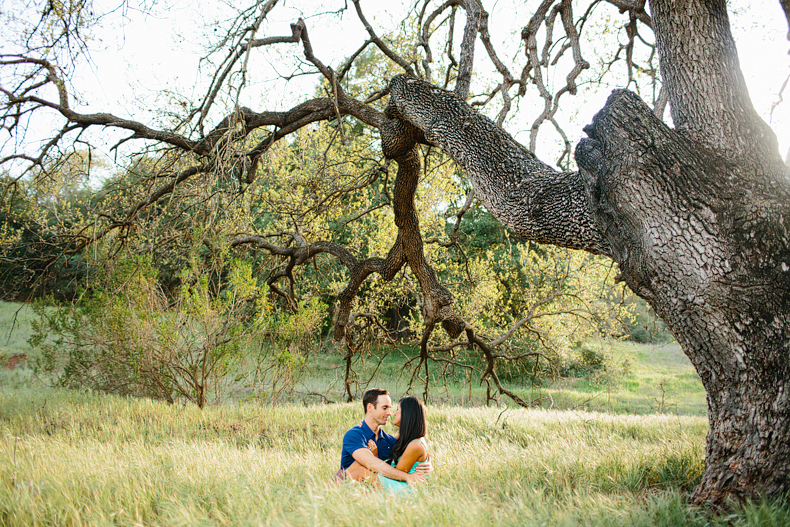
[0,304,790,526]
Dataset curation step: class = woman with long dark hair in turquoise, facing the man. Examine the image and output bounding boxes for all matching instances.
[378,395,428,492]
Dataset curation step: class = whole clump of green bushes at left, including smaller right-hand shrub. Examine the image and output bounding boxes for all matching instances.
[29,256,326,408]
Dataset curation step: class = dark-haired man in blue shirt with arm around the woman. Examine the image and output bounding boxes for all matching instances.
[335,388,433,483]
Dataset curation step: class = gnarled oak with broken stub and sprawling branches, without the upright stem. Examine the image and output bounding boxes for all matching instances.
[1,0,790,503]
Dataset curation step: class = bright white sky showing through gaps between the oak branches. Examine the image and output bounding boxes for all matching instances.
[6,0,790,169]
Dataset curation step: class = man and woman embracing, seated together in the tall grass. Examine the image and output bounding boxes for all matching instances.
[335,388,433,492]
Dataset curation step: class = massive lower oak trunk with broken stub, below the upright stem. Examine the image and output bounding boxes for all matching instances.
[576,91,790,502]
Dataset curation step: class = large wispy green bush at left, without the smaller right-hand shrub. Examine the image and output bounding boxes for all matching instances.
[30,257,262,408]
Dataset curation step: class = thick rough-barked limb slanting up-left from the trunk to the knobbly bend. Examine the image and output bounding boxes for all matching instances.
[390,76,609,254]
